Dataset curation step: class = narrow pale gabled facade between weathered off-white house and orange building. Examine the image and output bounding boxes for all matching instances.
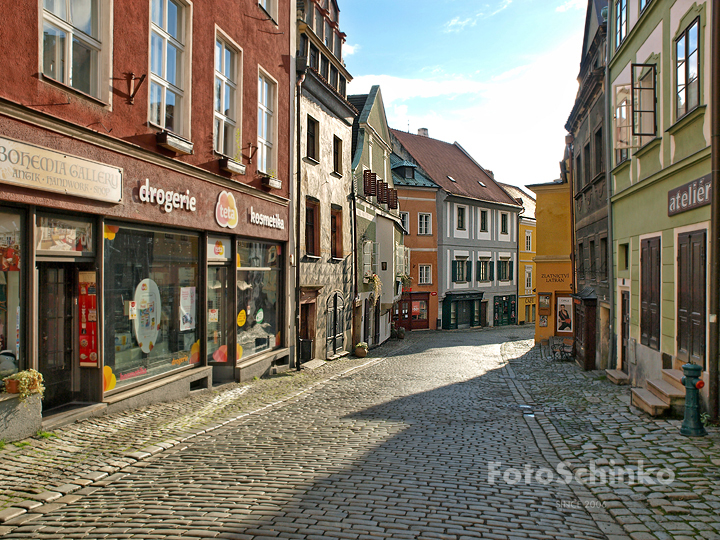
[348,86,406,347]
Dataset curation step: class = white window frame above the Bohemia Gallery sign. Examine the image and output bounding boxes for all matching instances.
[38,0,113,103]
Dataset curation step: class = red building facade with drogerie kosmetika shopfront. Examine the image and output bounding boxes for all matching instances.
[0,0,294,414]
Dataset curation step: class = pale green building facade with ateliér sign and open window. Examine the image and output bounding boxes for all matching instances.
[608,0,717,414]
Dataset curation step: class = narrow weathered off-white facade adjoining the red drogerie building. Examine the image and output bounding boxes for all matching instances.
[296,1,357,361]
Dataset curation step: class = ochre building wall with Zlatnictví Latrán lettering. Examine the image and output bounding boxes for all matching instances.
[527,180,575,343]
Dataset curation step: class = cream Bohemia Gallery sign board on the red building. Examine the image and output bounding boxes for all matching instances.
[0,137,123,203]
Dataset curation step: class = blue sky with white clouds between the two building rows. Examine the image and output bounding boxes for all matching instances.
[338,0,587,190]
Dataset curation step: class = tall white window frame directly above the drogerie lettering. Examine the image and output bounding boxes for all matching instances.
[148,0,192,139]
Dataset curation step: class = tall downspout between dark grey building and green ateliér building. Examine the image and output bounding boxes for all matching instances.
[603,12,617,369]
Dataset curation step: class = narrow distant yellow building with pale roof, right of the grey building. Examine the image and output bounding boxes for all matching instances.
[498,182,537,324]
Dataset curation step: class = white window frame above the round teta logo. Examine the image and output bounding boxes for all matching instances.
[213,27,243,157]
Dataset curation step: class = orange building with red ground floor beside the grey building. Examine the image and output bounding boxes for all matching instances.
[390,154,439,330]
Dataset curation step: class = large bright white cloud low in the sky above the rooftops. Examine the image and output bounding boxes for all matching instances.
[351,34,582,189]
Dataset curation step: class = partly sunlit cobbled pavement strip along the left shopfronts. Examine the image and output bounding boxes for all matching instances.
[0,341,416,535]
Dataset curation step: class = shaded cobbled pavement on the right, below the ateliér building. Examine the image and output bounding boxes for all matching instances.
[504,344,720,540]
